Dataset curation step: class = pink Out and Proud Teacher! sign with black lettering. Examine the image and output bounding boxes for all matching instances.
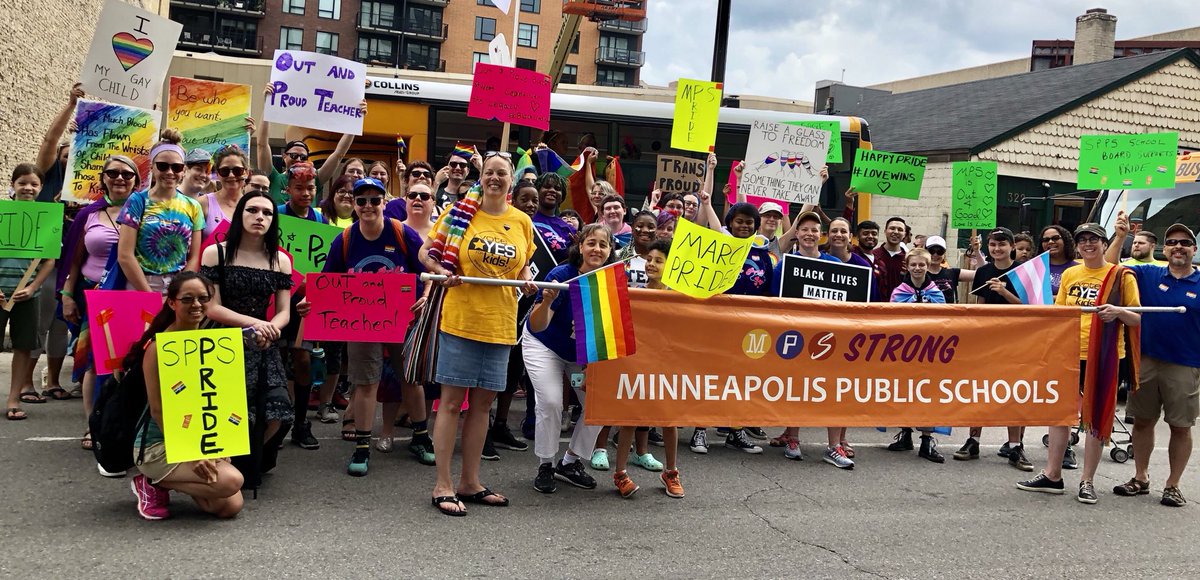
[304,274,416,342]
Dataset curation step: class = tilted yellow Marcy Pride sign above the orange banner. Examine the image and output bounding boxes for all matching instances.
[662,217,754,298]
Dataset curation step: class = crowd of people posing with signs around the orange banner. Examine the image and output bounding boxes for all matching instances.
[0,82,1200,519]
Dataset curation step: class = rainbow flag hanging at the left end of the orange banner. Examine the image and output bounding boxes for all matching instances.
[569,262,637,365]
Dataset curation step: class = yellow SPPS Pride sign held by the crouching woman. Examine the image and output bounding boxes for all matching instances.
[155,328,250,464]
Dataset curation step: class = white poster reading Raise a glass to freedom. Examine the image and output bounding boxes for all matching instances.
[738,121,829,204]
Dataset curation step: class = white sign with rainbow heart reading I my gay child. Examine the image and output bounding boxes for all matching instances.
[79,0,184,109]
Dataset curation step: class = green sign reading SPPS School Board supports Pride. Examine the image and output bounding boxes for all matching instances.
[1076,133,1180,190]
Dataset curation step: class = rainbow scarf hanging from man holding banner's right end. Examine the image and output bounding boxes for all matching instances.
[1080,265,1141,442]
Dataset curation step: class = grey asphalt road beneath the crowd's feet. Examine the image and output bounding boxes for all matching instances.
[0,355,1200,579]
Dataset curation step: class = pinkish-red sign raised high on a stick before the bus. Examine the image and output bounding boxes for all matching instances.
[467,62,551,131]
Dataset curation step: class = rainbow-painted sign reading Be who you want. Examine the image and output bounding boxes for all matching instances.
[167,77,250,154]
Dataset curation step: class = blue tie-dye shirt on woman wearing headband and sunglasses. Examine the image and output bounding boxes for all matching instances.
[116,191,204,275]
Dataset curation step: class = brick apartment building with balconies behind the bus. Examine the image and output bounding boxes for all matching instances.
[170,0,646,86]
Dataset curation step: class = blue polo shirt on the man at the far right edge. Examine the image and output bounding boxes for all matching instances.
[1129,264,1200,367]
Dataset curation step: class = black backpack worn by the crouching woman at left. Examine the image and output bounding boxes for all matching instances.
[88,357,149,473]
